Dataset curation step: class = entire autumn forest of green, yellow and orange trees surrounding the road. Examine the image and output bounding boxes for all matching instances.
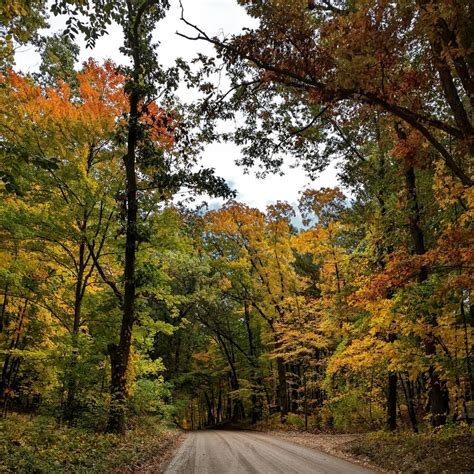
[0,0,474,472]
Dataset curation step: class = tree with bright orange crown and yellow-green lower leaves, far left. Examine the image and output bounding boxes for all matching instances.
[2,61,126,421]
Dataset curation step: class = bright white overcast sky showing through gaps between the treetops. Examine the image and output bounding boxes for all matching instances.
[16,0,337,210]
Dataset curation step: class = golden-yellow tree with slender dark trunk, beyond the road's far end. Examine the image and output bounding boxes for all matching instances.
[209,203,297,420]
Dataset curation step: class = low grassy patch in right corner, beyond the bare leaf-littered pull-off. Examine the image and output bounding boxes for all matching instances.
[342,427,474,473]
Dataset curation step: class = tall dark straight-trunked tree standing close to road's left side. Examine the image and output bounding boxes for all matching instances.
[48,0,231,433]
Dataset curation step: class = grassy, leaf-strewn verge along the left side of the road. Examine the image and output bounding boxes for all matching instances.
[0,414,179,474]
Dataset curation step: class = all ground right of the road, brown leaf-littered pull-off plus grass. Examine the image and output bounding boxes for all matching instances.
[252,425,474,474]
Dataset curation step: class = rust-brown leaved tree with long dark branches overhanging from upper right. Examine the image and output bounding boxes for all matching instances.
[182,0,473,186]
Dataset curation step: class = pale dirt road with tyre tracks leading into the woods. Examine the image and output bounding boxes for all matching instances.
[165,430,373,474]
